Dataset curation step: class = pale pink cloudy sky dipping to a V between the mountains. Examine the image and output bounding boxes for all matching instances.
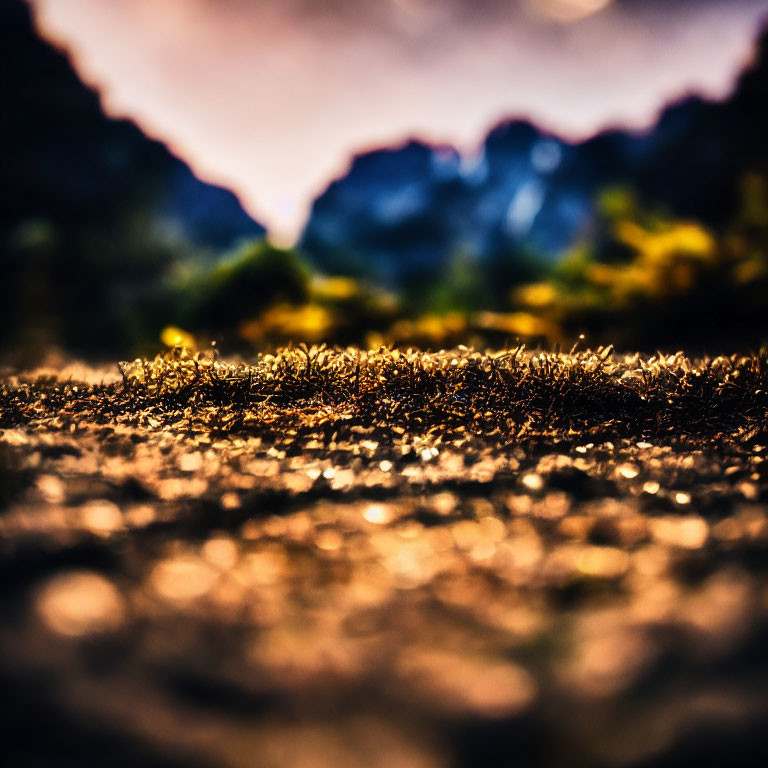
[29,0,768,242]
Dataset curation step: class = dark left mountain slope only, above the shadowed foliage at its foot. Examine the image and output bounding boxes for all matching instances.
[0,0,264,248]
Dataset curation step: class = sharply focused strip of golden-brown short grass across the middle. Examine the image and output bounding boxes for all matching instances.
[0,345,768,440]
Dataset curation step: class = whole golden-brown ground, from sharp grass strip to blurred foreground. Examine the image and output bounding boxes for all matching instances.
[0,349,768,768]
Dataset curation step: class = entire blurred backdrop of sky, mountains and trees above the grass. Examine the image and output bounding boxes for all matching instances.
[0,0,768,365]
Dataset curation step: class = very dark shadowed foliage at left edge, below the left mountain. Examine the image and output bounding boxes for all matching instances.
[0,216,184,364]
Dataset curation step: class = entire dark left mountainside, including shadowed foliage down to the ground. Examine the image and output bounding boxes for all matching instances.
[0,0,264,352]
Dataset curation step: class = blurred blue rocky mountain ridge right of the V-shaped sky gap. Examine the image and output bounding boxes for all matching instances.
[302,25,768,286]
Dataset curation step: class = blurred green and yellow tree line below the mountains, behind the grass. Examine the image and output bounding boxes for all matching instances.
[106,174,768,352]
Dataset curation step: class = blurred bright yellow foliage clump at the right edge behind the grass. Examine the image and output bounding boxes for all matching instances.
[513,183,768,349]
